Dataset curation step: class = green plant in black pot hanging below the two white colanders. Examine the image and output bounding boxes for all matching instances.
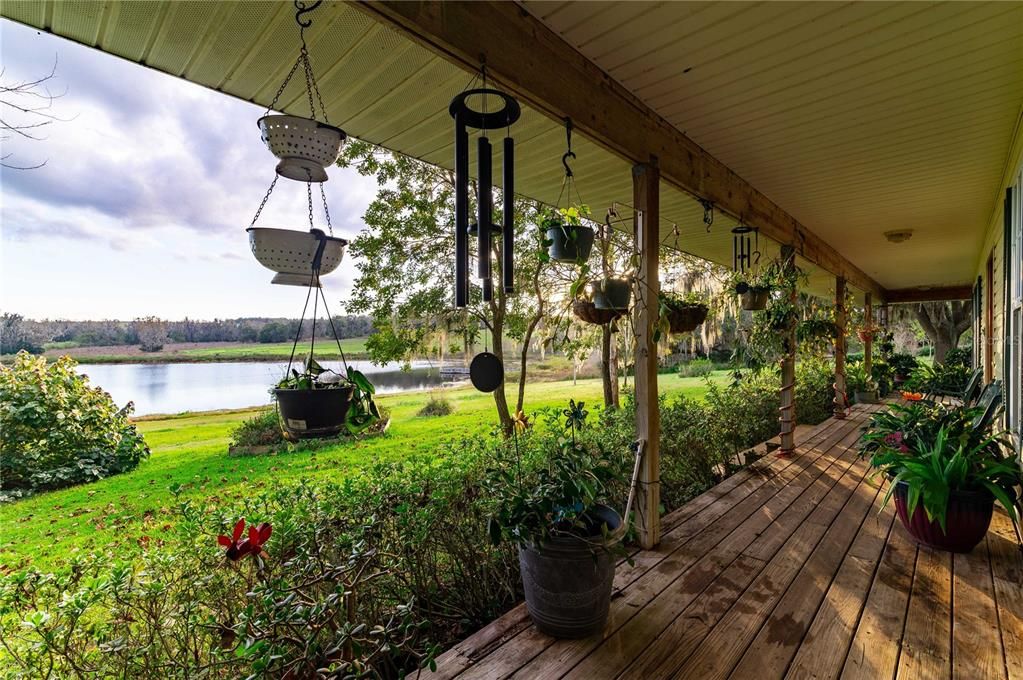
[273,354,380,439]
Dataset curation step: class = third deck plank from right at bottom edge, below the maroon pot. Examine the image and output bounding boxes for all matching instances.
[895,546,952,680]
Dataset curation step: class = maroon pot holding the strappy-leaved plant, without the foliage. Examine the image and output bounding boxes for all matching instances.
[895,482,994,552]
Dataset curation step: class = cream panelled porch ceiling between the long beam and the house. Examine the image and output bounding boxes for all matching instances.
[525,1,1023,288]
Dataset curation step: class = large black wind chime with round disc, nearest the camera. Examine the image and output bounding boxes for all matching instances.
[448,67,522,392]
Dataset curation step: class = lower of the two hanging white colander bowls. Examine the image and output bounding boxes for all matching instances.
[248,227,348,285]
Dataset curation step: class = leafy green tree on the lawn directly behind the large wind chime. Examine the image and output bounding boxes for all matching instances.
[339,140,548,432]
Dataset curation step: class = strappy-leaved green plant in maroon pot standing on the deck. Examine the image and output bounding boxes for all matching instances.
[860,401,1023,552]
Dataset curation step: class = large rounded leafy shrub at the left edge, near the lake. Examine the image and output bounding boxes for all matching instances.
[0,352,149,495]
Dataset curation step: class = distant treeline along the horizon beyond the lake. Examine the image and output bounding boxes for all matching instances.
[0,314,373,354]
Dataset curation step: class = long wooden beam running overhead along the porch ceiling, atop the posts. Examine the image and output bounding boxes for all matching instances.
[357,0,884,299]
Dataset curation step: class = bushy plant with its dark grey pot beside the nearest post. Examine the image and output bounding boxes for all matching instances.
[485,401,625,638]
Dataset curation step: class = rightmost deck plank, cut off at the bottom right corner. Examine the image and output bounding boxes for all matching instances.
[987,510,1023,680]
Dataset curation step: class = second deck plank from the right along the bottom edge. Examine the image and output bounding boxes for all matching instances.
[952,539,1006,680]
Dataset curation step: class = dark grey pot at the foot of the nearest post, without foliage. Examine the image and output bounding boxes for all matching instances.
[519,506,622,639]
